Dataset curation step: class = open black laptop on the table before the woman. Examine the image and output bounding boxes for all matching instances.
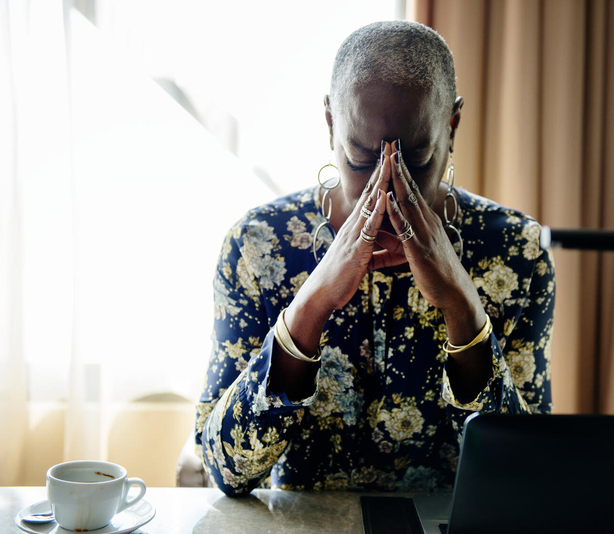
[361,414,614,534]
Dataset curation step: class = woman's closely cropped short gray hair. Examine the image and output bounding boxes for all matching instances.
[330,20,456,118]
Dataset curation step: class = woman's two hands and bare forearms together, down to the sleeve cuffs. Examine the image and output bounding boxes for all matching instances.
[282,141,491,402]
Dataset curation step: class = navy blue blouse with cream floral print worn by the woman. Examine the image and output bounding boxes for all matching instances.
[196,189,554,495]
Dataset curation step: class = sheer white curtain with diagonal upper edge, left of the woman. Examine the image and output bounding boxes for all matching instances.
[0,0,273,484]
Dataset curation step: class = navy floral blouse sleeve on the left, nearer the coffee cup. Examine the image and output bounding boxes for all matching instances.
[196,224,317,495]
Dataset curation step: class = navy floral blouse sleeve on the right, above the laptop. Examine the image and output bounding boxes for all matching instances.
[442,221,555,435]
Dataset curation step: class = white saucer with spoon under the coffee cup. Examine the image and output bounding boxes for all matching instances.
[15,499,156,534]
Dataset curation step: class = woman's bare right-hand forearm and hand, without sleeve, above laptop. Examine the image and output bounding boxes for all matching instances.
[381,142,492,402]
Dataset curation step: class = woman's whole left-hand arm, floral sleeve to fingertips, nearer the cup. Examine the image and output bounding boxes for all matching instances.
[197,145,402,494]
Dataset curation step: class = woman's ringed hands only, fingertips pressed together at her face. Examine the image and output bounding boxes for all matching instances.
[312,141,481,326]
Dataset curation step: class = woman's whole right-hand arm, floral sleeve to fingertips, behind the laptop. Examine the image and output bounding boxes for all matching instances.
[386,144,554,415]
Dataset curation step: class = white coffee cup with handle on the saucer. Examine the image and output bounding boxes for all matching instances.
[47,460,147,532]
